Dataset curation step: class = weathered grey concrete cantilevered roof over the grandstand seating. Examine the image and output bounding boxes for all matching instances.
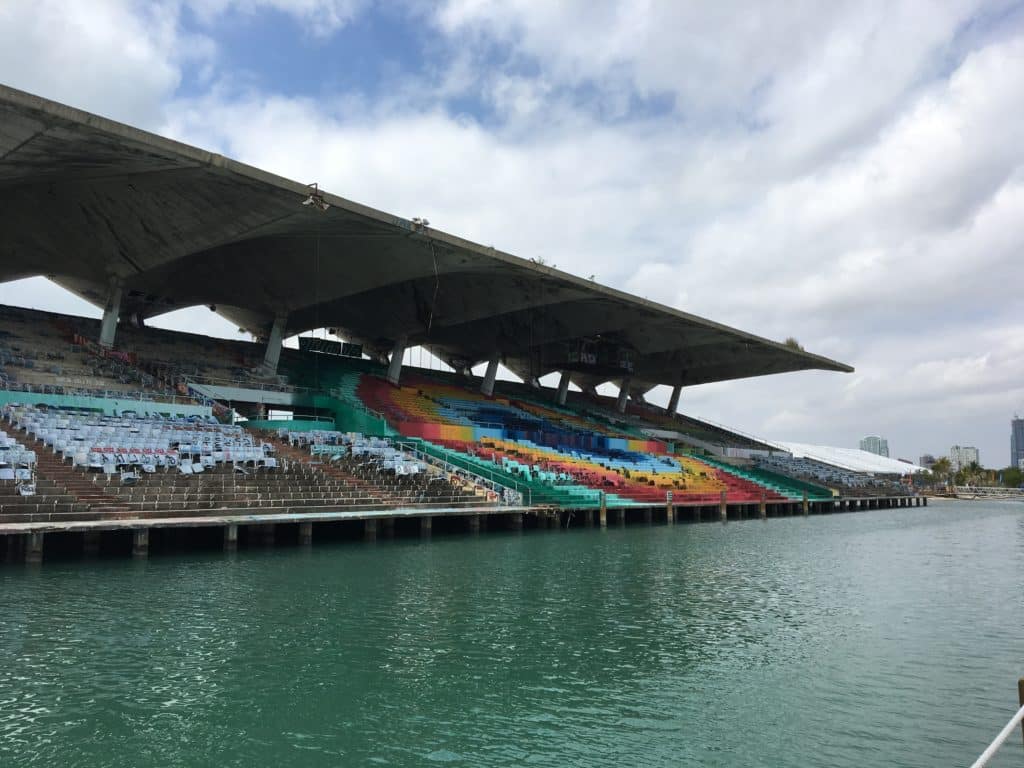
[0,85,852,388]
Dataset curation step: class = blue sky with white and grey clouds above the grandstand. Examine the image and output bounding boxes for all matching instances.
[0,0,1024,466]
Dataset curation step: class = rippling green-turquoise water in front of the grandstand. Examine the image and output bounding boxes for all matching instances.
[0,503,1024,767]
